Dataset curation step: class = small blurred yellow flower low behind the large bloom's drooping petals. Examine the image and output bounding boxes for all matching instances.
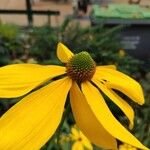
[70,127,93,150]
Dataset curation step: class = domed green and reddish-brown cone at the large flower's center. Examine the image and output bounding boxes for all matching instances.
[66,51,96,82]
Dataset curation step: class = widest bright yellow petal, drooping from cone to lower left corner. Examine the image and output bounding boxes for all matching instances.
[0,78,71,150]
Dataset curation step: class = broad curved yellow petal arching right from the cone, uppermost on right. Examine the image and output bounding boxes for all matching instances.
[94,68,144,105]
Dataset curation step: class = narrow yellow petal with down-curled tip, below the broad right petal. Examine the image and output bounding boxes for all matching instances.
[92,79,134,129]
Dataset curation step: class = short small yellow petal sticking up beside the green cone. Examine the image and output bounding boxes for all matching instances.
[57,43,74,63]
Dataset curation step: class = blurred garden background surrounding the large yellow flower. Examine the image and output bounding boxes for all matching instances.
[0,0,150,150]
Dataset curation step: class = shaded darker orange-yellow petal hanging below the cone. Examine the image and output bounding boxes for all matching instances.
[70,82,117,149]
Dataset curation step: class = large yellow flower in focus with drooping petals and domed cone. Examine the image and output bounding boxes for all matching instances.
[0,43,148,150]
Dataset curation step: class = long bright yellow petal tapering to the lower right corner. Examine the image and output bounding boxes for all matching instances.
[82,82,148,150]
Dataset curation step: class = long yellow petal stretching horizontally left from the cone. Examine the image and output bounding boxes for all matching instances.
[0,64,65,98]
